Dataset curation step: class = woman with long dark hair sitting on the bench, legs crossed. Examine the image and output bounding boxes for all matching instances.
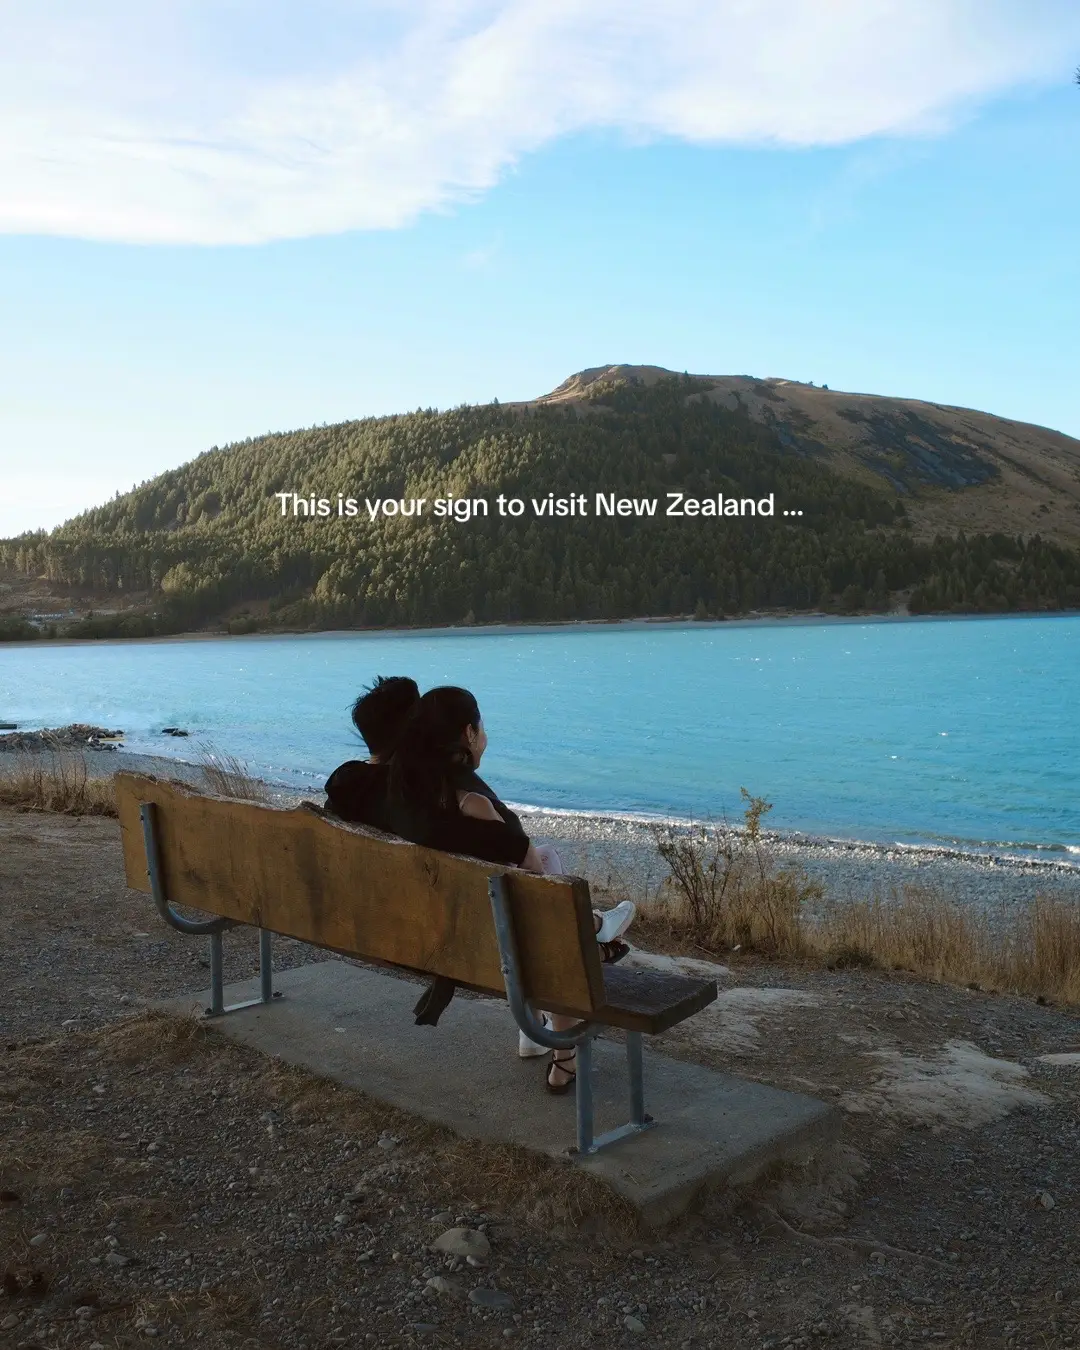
[385,684,635,1094]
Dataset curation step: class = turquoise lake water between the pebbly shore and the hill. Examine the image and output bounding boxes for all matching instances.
[0,616,1080,856]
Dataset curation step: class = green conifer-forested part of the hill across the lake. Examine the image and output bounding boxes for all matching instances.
[0,377,1080,636]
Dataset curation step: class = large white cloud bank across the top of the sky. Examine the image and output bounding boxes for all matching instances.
[0,0,1080,244]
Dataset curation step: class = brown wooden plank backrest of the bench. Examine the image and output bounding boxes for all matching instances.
[116,774,605,1015]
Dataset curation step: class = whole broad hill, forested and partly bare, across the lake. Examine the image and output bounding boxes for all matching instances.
[0,366,1080,636]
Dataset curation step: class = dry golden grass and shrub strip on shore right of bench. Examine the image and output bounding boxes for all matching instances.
[635,790,1080,1003]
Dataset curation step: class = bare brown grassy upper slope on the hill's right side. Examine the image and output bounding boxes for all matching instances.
[536,366,1080,544]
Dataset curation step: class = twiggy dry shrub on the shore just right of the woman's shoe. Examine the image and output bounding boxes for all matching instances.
[647,787,821,956]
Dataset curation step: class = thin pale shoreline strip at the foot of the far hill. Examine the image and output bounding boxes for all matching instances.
[0,609,1080,652]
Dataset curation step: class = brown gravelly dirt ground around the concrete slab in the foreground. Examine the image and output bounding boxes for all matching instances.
[0,811,1080,1350]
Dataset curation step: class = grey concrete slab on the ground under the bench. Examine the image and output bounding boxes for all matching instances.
[159,961,840,1224]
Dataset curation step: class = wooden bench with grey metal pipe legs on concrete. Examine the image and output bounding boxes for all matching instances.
[116,774,717,1153]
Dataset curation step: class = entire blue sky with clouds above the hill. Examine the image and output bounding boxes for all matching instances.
[0,0,1080,537]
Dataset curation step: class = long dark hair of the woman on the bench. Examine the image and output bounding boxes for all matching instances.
[389,684,481,814]
